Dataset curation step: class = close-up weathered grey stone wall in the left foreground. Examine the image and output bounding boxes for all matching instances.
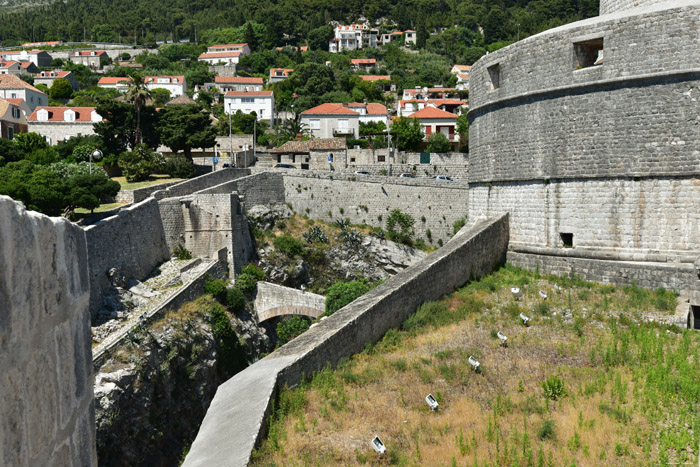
[0,196,97,467]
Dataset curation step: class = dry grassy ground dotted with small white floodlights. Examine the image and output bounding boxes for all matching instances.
[253,266,700,466]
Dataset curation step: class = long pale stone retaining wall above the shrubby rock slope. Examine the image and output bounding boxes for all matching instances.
[284,172,469,243]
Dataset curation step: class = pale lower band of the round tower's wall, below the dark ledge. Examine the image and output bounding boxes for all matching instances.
[469,177,700,261]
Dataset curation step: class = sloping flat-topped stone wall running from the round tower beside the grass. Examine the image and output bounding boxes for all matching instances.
[183,215,508,467]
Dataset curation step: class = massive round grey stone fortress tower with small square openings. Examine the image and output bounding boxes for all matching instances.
[469,0,700,327]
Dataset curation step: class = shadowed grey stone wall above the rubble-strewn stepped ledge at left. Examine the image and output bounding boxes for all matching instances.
[85,198,170,313]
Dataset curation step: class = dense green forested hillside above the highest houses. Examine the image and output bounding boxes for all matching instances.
[0,0,598,53]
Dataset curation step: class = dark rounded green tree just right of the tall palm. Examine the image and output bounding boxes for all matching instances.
[159,104,216,161]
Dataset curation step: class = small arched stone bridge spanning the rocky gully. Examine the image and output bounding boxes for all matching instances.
[255,281,326,323]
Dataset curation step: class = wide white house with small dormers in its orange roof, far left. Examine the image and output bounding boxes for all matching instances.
[27,107,102,144]
